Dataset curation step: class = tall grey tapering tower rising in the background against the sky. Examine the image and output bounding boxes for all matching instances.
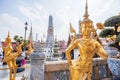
[45,15,54,49]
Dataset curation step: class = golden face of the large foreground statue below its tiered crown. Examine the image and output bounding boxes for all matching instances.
[81,22,93,36]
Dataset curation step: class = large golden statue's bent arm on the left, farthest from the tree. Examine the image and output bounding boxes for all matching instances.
[66,42,76,65]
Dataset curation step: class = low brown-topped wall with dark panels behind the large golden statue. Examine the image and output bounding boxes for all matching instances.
[45,58,112,80]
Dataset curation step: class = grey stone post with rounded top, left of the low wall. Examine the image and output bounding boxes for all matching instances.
[30,52,45,80]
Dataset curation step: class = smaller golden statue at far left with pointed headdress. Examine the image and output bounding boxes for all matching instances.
[3,33,33,80]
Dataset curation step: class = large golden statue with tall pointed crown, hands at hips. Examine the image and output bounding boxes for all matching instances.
[66,0,108,80]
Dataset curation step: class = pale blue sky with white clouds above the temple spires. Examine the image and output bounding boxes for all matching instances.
[0,0,120,40]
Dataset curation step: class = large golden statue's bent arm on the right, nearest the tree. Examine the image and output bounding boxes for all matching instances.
[95,42,108,59]
